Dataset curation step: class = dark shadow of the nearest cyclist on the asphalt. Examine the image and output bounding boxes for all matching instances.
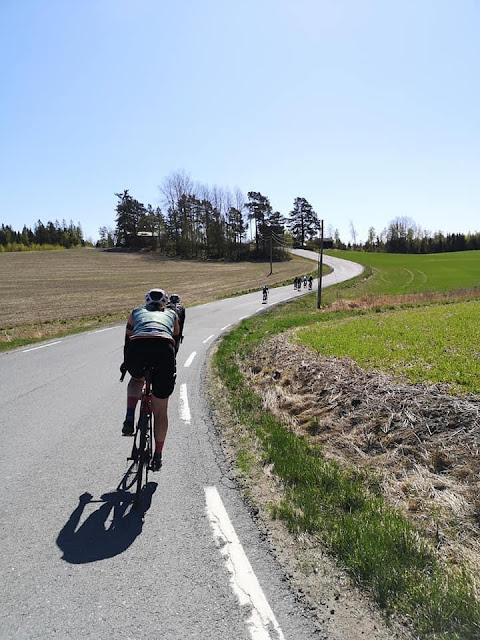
[57,482,157,564]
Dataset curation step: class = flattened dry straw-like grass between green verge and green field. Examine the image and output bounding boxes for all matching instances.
[243,334,480,573]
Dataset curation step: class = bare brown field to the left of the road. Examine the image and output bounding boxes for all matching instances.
[0,249,313,344]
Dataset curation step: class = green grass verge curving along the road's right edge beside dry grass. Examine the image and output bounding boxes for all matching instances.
[214,312,480,640]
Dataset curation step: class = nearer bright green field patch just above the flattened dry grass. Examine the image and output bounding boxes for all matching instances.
[297,300,480,393]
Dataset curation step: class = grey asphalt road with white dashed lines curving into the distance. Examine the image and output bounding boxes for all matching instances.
[0,252,361,640]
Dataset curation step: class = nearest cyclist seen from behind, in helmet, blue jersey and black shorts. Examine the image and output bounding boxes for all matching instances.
[120,289,181,471]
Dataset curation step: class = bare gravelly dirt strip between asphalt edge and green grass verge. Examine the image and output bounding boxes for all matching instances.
[207,364,404,640]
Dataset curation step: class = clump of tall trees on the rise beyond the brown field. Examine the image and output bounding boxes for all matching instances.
[106,172,320,260]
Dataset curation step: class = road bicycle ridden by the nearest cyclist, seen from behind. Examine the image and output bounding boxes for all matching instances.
[127,365,153,507]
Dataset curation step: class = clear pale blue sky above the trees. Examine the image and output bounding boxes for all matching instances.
[0,0,480,242]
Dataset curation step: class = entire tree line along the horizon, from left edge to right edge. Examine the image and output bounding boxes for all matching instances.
[0,171,480,260]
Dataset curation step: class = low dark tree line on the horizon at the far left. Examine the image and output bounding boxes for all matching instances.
[0,220,85,251]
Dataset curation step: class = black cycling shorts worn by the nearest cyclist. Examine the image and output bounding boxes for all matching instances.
[126,338,176,398]
